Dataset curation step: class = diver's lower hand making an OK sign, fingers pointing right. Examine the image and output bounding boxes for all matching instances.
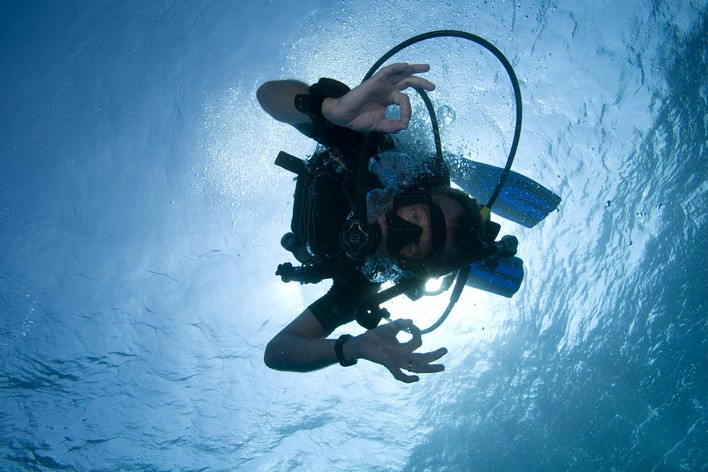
[343,320,447,383]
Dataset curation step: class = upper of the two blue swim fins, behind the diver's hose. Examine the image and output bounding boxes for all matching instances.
[445,155,561,228]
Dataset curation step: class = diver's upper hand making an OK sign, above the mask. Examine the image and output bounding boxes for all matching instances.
[322,63,435,133]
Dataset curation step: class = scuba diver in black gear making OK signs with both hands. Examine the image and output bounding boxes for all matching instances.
[257,55,560,383]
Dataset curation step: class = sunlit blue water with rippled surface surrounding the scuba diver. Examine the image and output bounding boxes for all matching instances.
[0,0,708,471]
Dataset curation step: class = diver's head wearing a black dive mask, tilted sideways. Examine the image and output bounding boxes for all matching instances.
[377,187,485,275]
